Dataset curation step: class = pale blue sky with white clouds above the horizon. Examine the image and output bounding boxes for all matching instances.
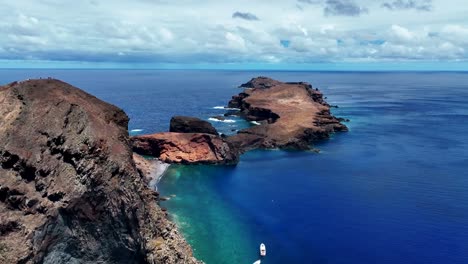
[0,0,468,67]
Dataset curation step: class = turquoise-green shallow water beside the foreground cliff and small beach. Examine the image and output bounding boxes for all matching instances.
[159,166,258,263]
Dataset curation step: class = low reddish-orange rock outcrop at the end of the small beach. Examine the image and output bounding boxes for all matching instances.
[132,132,239,164]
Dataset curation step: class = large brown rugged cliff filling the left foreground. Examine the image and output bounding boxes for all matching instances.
[0,80,197,263]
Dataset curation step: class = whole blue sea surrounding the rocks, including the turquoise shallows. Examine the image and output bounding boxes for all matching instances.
[0,70,468,264]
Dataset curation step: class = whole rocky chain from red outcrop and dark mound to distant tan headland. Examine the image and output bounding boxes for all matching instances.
[132,77,348,162]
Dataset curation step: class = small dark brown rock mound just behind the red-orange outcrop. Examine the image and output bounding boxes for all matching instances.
[169,116,218,135]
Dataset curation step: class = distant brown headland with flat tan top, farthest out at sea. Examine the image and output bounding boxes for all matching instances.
[227,77,348,152]
